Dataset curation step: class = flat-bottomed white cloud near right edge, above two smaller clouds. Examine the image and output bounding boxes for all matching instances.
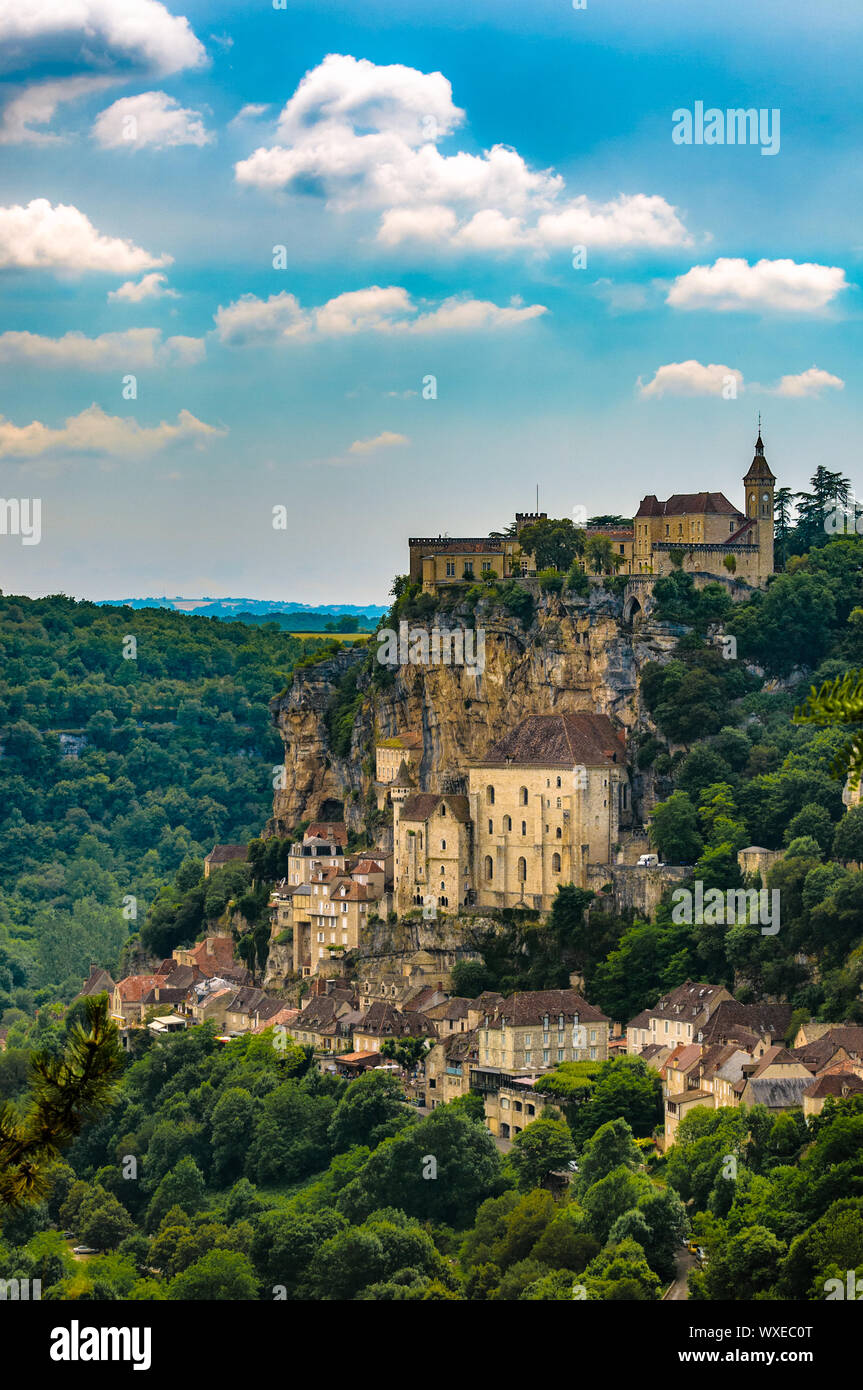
[667,257,848,314]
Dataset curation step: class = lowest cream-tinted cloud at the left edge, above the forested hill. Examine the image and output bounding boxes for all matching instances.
[0,404,227,459]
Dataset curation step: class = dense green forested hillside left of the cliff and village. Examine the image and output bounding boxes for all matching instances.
[0,596,333,1022]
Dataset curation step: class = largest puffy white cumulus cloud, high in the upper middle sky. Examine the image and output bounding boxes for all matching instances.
[235,54,691,252]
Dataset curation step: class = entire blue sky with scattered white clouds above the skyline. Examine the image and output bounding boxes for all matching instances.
[0,0,863,605]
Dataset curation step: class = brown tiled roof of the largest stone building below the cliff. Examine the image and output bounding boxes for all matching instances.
[477,712,625,767]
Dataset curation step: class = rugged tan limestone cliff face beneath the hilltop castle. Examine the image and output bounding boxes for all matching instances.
[270,589,675,834]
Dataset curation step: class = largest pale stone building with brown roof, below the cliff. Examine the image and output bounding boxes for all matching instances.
[470,713,631,912]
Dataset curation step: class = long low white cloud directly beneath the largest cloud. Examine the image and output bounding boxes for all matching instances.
[214,285,548,348]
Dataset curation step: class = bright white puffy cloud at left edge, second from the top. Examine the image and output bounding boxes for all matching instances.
[0,197,172,275]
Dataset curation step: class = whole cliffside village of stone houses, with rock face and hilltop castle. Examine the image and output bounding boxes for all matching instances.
[83,432,863,1148]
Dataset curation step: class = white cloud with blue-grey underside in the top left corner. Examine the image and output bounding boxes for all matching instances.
[0,0,207,143]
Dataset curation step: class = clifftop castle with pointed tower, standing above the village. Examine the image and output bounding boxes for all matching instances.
[409,423,775,595]
